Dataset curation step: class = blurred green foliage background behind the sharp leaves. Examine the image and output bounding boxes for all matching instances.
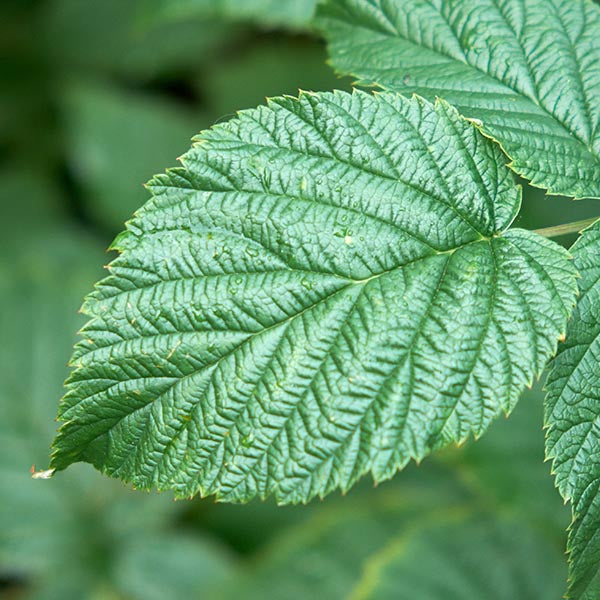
[0,0,597,600]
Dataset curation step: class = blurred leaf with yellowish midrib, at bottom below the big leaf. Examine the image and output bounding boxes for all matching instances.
[225,464,566,600]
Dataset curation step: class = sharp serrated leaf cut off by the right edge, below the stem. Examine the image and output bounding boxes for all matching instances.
[546,222,600,600]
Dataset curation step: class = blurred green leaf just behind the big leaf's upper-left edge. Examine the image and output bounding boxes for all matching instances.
[61,85,205,229]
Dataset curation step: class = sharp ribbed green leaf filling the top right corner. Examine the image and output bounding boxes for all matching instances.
[319,0,600,197]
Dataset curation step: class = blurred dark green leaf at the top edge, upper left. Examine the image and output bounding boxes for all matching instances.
[39,0,234,81]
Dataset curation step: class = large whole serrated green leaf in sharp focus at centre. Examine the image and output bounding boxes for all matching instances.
[52,92,576,502]
